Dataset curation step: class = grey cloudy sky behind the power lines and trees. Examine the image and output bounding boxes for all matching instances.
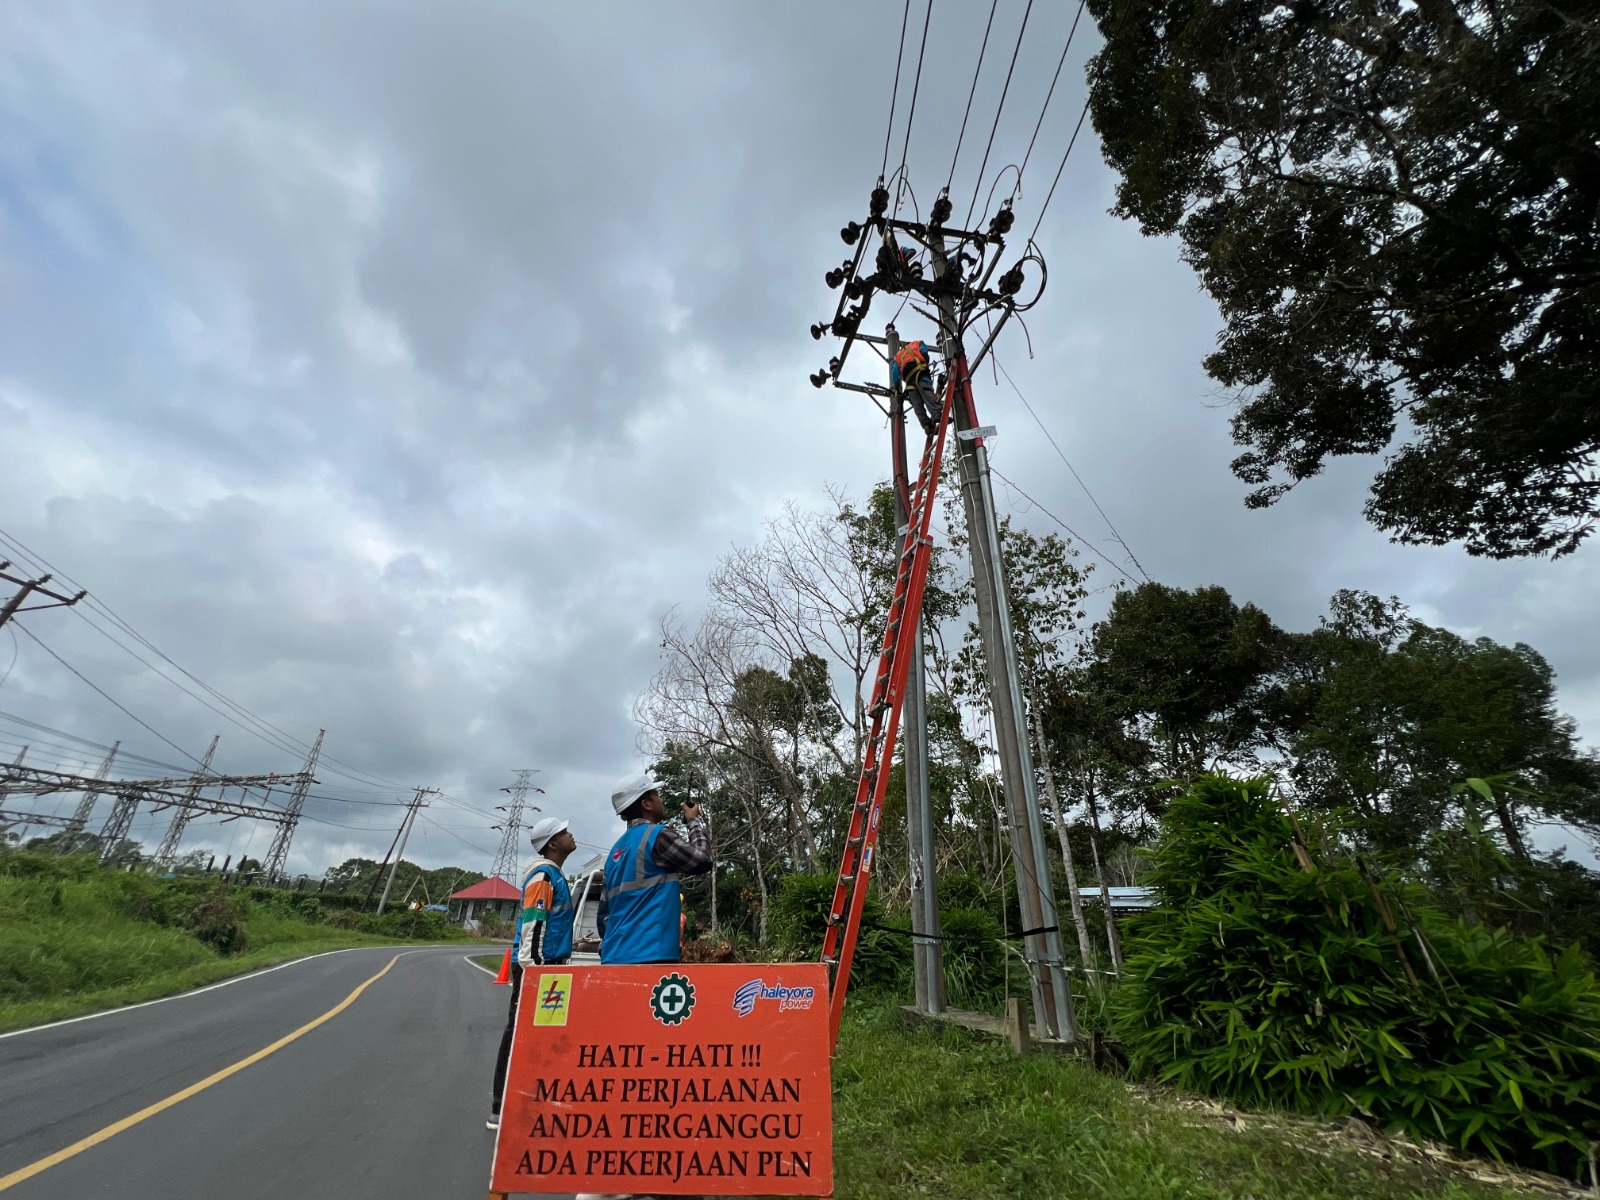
[0,0,1600,874]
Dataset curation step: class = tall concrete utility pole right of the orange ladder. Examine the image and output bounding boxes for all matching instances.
[928,234,1077,1042]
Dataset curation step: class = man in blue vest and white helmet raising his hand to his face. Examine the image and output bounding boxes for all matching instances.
[598,774,712,963]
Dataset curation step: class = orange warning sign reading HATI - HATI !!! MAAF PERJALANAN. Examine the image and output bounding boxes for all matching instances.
[491,963,834,1195]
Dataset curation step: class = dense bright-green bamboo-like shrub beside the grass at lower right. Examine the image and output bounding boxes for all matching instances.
[1112,776,1600,1178]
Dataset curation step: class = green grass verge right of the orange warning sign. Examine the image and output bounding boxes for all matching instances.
[834,1000,1526,1200]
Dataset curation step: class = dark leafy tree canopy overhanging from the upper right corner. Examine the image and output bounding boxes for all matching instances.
[1090,0,1600,558]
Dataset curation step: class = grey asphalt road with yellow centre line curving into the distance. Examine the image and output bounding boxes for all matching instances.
[0,947,569,1200]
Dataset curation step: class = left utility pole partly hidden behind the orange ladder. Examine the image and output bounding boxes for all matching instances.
[883,325,944,1013]
